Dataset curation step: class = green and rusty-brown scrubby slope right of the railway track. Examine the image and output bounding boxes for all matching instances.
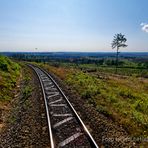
[39,64,148,137]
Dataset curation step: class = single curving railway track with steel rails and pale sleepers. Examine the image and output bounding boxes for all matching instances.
[29,65,98,148]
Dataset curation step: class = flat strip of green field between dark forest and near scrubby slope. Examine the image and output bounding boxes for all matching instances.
[44,59,148,78]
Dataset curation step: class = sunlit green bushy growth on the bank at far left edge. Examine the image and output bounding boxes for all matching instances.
[0,56,20,101]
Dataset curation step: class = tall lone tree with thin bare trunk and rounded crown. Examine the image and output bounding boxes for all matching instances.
[112,33,127,73]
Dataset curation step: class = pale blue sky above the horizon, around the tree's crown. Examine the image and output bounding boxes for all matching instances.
[0,0,148,52]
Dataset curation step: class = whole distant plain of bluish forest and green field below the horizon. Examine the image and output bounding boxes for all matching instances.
[2,52,148,77]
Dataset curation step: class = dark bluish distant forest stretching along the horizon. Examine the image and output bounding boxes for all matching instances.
[1,52,148,68]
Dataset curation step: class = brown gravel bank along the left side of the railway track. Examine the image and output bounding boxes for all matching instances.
[0,66,49,148]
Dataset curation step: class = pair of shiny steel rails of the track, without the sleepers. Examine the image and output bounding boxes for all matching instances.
[29,64,99,148]
